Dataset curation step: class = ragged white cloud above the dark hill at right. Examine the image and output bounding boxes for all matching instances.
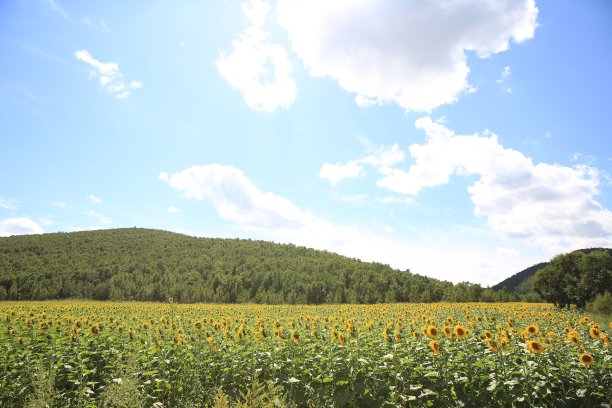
[377,117,612,251]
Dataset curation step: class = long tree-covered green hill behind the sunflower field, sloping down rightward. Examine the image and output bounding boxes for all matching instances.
[0,228,474,303]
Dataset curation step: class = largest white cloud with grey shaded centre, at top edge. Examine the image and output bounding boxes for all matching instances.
[277,0,538,111]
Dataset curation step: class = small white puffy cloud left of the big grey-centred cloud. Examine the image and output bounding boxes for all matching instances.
[216,0,297,112]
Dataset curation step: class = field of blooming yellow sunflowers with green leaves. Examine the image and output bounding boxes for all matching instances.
[0,302,612,407]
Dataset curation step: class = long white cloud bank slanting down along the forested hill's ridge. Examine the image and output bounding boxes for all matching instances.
[159,164,535,284]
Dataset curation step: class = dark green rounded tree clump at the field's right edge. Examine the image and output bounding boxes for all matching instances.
[533,250,612,308]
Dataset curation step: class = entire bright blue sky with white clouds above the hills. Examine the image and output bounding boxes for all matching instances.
[0,0,612,285]
